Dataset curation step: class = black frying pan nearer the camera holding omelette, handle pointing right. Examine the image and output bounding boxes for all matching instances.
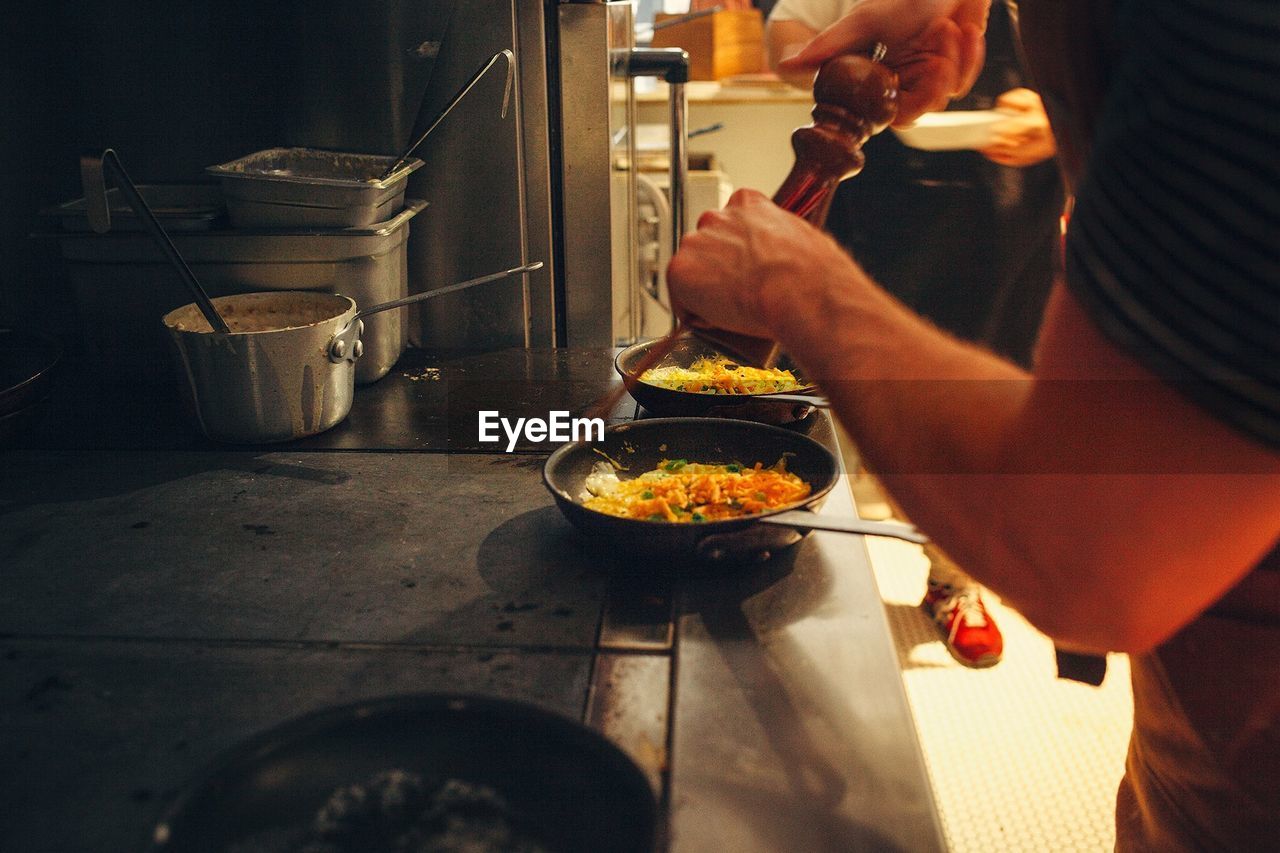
[543,418,927,560]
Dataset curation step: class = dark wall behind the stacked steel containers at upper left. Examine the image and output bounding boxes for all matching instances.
[0,0,454,338]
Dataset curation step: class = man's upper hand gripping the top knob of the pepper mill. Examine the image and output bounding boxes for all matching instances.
[778,0,991,126]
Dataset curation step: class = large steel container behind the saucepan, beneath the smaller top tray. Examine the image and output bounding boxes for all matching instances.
[56,200,426,383]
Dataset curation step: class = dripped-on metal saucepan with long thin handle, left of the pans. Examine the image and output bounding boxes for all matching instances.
[164,261,543,444]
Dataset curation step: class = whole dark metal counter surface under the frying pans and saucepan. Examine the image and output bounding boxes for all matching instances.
[0,351,942,853]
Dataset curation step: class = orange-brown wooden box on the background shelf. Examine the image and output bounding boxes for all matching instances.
[653,9,765,79]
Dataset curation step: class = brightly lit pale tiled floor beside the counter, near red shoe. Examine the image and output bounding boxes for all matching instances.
[855,466,1133,853]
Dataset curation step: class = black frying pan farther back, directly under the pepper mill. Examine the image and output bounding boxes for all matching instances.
[613,336,827,424]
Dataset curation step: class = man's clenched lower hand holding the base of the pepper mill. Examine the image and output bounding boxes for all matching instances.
[667,190,865,338]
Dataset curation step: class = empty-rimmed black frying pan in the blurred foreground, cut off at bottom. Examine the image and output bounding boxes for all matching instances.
[151,694,657,853]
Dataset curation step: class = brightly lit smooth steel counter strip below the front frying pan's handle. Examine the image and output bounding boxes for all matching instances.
[671,471,943,853]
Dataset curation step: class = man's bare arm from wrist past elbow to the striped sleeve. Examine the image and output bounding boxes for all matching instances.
[760,272,1280,651]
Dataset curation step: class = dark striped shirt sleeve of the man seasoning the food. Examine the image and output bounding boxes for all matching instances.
[1066,0,1280,447]
